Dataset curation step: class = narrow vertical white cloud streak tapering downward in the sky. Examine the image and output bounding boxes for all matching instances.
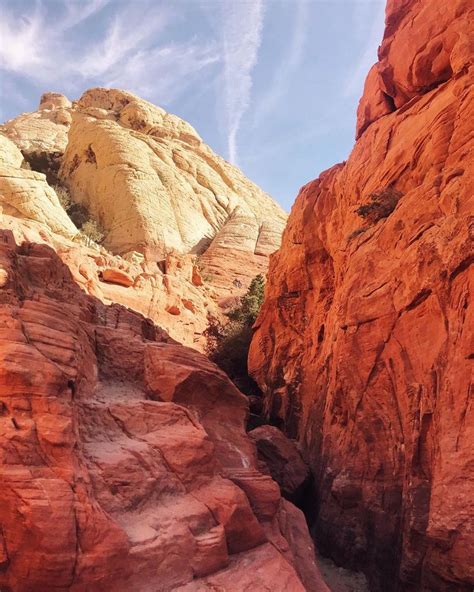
[220,0,265,164]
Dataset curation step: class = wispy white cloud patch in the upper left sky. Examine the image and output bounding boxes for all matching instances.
[0,0,219,110]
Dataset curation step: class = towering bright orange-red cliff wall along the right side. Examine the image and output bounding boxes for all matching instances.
[250,0,474,592]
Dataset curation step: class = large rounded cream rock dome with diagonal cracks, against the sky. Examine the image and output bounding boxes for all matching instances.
[61,89,286,283]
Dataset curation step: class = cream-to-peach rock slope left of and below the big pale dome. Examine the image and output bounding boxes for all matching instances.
[0,134,220,349]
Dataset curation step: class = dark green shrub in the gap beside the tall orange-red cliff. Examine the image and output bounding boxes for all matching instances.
[205,275,265,395]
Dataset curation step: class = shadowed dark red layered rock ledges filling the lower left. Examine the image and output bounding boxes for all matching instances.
[0,231,328,592]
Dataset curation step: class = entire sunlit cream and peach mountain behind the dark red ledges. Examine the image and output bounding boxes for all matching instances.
[0,88,286,350]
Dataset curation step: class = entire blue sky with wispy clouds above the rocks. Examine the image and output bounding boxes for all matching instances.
[0,0,385,210]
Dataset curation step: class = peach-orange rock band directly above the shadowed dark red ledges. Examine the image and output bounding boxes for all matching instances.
[0,214,220,350]
